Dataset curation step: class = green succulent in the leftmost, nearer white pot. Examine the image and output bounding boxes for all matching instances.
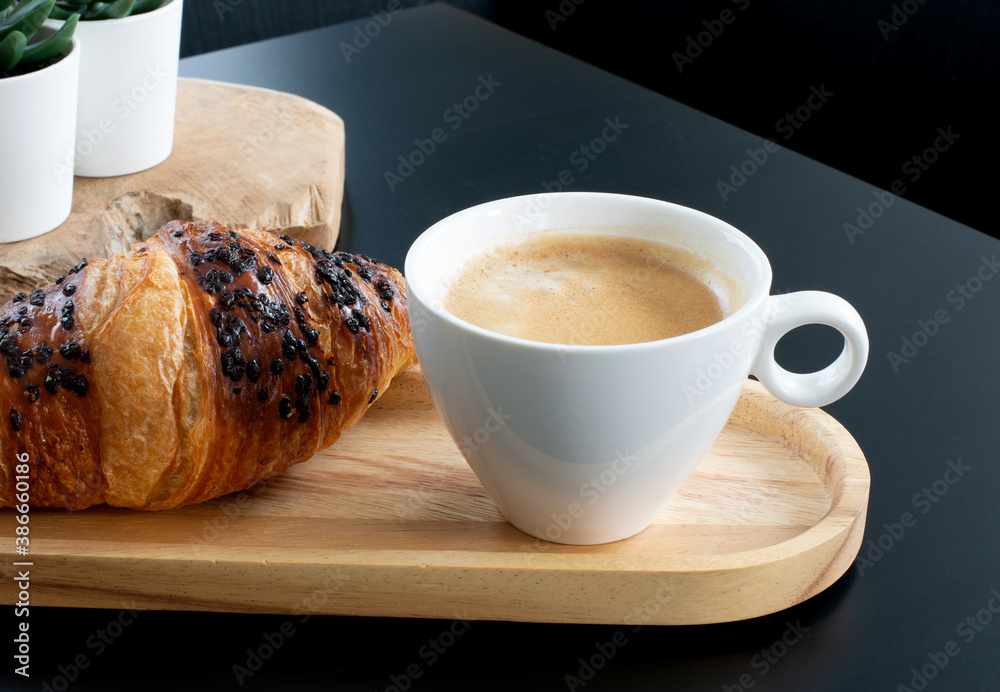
[0,0,80,74]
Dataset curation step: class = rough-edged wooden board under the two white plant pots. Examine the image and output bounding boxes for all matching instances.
[0,78,344,303]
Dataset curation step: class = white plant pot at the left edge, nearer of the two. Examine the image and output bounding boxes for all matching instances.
[0,27,81,243]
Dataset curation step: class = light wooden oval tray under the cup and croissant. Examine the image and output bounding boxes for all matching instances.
[0,370,869,624]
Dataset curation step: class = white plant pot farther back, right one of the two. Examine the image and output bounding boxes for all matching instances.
[76,0,183,178]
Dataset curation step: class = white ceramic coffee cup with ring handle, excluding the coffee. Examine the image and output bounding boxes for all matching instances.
[405,192,868,545]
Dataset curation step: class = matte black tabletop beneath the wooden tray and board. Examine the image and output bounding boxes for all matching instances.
[9,5,1000,692]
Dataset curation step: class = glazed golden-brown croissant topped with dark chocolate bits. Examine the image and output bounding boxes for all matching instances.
[0,221,416,510]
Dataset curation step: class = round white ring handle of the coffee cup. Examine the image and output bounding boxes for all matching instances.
[751,291,868,407]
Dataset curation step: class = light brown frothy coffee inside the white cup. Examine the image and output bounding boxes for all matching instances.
[444,231,734,346]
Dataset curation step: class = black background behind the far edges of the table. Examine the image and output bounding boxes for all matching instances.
[182,0,1000,237]
